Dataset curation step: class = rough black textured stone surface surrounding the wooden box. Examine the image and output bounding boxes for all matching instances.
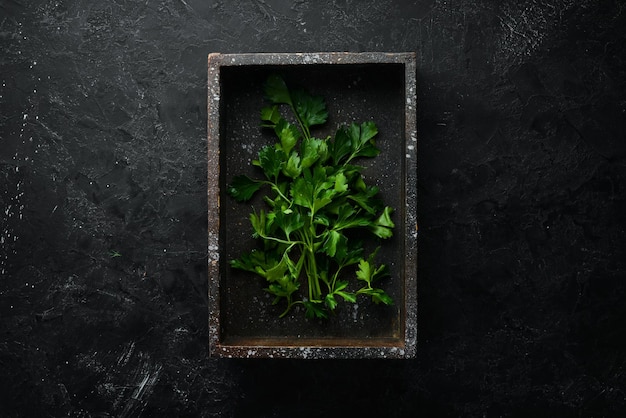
[0,0,626,417]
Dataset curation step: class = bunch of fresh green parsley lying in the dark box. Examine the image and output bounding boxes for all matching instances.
[227,75,394,318]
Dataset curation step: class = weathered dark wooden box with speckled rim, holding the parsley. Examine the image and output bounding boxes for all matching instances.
[208,52,417,358]
